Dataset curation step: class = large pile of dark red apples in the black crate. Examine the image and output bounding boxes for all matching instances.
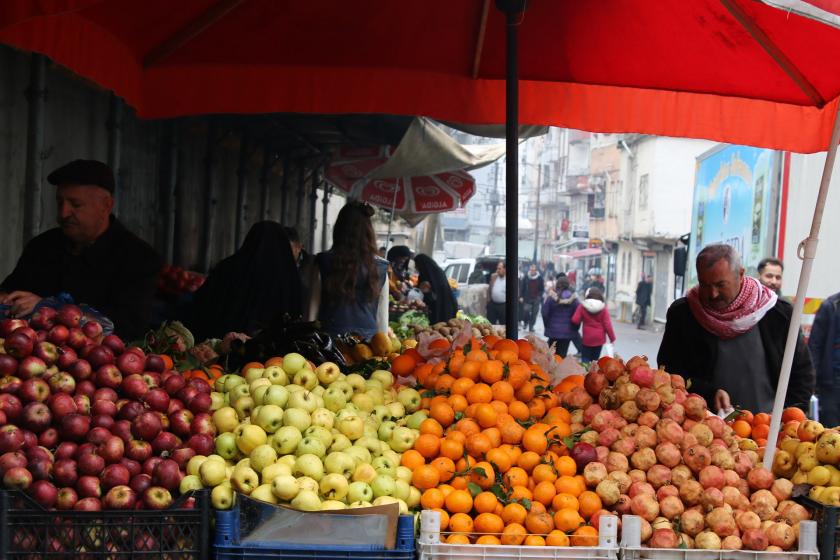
[0,305,216,511]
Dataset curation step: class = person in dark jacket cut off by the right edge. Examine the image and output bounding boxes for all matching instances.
[808,293,840,426]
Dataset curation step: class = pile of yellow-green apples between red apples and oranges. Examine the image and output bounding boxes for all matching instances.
[181,353,420,513]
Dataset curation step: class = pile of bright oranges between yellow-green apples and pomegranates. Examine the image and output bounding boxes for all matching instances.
[392,337,605,546]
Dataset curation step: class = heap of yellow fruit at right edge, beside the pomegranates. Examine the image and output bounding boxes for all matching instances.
[773,411,840,506]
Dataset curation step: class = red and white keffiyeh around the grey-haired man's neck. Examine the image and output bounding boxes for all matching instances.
[686,276,777,340]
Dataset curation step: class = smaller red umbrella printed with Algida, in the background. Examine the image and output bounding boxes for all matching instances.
[325,146,475,217]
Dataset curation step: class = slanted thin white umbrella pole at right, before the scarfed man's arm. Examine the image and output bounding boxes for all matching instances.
[764,104,840,469]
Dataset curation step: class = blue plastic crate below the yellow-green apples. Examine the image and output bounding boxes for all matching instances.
[213,496,415,560]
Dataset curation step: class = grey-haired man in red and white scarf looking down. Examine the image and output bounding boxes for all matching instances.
[657,244,815,412]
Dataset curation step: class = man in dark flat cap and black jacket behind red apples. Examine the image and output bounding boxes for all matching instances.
[0,159,162,339]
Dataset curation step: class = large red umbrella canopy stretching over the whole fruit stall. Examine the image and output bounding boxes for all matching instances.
[0,0,840,152]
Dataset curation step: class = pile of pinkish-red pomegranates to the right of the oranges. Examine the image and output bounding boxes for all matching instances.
[563,357,809,551]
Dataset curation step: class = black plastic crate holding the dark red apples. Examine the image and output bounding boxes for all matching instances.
[0,490,211,560]
